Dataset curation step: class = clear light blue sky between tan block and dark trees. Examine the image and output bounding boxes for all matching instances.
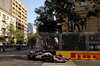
[19,0,45,24]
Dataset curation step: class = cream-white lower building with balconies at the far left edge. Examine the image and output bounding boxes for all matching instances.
[0,9,16,45]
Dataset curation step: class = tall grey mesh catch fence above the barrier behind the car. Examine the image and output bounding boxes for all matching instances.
[37,32,100,51]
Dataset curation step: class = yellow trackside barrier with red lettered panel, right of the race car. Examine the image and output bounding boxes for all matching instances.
[56,51,100,60]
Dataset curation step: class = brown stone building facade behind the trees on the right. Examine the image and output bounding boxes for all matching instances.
[58,0,100,32]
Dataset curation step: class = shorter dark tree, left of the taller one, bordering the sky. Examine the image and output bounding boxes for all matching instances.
[35,6,56,33]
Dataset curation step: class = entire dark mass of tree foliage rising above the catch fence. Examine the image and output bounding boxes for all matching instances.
[35,0,88,32]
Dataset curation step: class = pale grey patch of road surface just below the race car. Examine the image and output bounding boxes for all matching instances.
[42,60,77,66]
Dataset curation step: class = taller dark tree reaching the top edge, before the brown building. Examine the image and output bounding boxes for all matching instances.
[45,0,85,32]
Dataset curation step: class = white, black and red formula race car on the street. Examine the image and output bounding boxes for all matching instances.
[27,51,69,62]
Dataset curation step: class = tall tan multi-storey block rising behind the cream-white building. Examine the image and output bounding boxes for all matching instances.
[0,0,28,42]
